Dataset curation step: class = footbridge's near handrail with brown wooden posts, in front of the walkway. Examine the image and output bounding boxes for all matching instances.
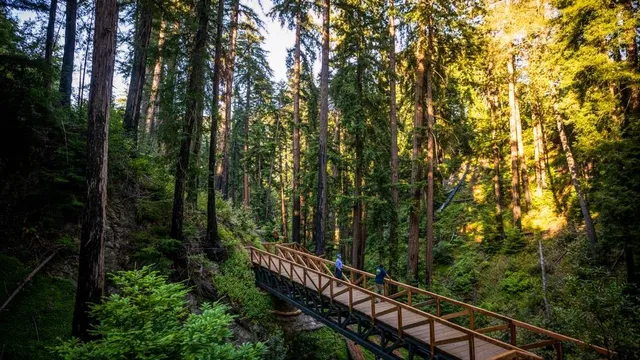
[247,246,542,360]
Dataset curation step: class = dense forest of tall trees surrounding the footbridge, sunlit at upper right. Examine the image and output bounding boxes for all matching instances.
[0,0,640,359]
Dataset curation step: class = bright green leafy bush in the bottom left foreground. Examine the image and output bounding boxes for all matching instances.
[53,267,263,359]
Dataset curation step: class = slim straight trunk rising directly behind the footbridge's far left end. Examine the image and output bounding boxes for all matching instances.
[291,13,301,243]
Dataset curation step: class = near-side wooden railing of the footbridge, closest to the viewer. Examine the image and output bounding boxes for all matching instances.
[248,244,542,360]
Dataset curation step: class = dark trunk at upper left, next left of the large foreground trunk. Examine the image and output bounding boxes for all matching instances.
[60,0,78,108]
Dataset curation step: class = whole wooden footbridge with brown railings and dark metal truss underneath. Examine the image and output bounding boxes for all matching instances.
[248,243,614,360]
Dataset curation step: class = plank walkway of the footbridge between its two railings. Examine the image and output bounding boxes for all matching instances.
[251,252,520,359]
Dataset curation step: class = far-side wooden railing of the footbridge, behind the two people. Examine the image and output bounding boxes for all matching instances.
[270,244,615,359]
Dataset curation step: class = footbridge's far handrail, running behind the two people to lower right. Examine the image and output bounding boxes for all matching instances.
[270,243,615,357]
